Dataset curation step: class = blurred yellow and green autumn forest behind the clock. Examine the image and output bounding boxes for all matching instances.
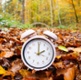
[0,0,81,28]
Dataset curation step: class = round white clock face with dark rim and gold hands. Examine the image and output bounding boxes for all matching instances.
[22,38,54,70]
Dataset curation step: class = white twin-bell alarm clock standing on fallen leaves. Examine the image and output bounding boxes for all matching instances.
[21,30,57,71]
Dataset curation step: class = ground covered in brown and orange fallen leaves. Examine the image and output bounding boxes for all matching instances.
[0,28,81,80]
